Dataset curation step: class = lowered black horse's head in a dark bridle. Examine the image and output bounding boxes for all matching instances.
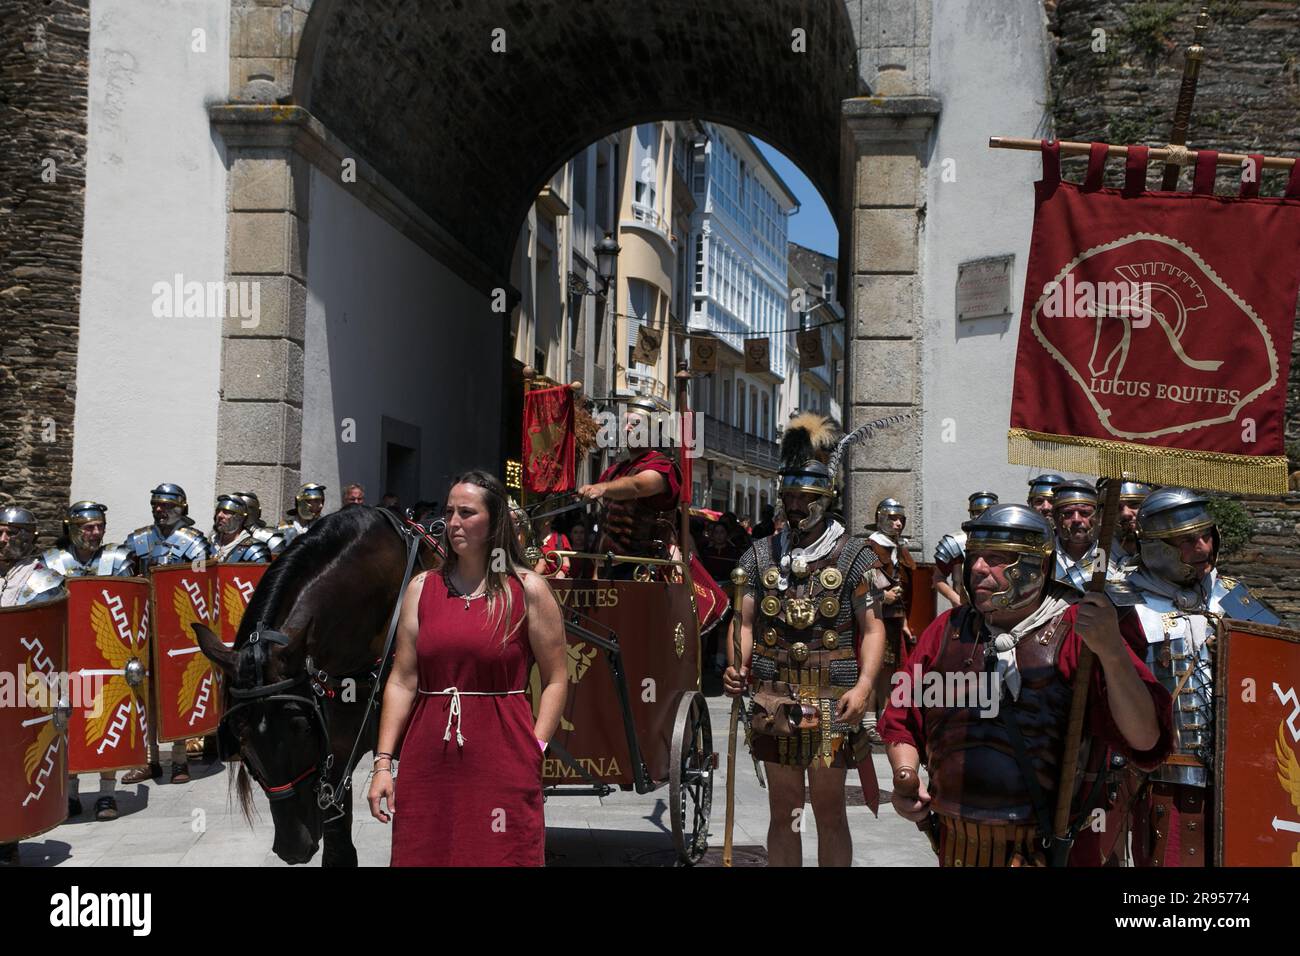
[192,624,333,864]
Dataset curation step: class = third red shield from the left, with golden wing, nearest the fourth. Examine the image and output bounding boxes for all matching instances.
[150,564,221,743]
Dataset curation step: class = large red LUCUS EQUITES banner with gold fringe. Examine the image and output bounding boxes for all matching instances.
[1008,140,1300,493]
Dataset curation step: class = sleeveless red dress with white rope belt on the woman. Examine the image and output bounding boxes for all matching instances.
[391,574,546,866]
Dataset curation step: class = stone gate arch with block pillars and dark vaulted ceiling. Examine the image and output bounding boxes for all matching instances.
[218,0,939,540]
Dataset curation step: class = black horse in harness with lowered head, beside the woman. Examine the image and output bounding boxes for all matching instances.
[194,506,436,866]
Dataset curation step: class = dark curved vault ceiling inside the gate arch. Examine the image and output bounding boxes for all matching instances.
[294,0,858,277]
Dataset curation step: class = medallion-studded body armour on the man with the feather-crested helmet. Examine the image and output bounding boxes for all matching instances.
[742,535,875,769]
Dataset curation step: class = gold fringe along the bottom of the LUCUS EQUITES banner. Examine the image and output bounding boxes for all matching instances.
[1006,428,1287,494]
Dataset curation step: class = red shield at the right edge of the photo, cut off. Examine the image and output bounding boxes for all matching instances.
[1214,620,1300,866]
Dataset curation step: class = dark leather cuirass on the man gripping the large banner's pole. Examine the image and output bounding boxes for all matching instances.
[923,607,1071,823]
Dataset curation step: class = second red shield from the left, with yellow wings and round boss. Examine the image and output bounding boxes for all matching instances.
[68,578,150,774]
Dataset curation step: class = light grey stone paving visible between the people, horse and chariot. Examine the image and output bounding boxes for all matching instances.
[21,697,935,866]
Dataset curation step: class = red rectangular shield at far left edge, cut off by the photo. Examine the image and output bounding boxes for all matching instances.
[0,598,68,843]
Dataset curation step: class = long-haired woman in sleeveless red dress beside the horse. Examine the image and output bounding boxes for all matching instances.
[369,471,567,866]
